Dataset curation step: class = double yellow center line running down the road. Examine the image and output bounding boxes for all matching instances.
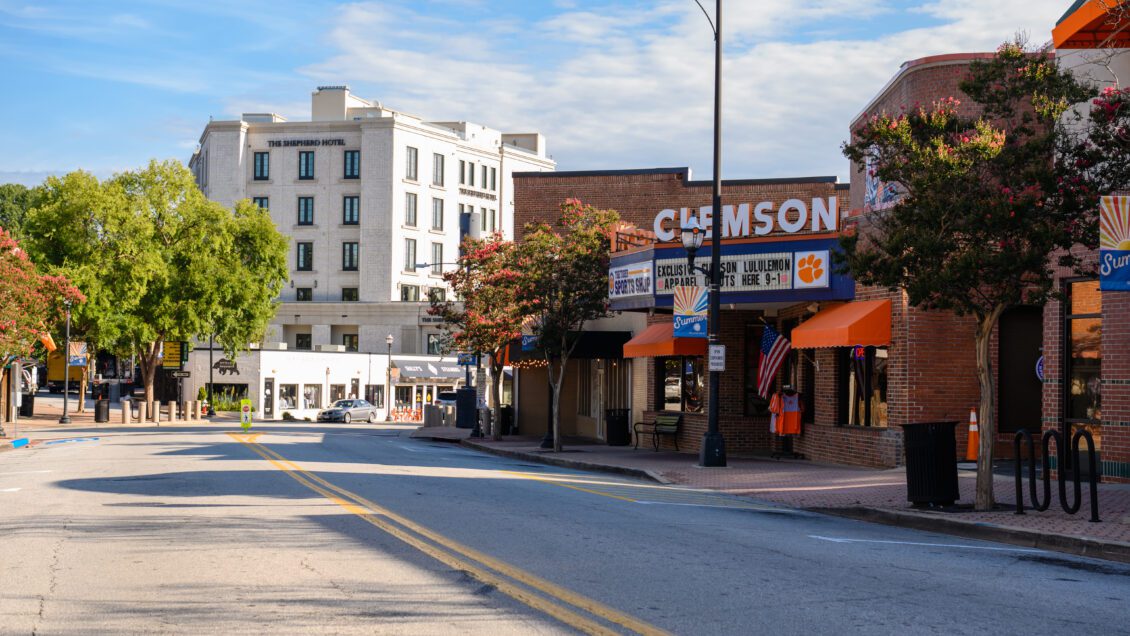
[228,433,667,635]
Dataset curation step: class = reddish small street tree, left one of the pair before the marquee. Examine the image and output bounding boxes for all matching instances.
[428,233,525,439]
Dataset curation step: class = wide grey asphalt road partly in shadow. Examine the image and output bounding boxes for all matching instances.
[0,422,1130,635]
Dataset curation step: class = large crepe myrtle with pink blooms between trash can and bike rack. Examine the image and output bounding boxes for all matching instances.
[840,40,1099,511]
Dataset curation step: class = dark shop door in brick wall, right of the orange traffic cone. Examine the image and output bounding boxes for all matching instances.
[998,306,1044,435]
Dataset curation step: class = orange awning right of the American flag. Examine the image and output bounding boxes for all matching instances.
[792,300,890,349]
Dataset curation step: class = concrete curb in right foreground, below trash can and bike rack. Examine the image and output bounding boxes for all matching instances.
[805,507,1130,563]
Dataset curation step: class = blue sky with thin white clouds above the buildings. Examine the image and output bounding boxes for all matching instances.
[0,0,1070,184]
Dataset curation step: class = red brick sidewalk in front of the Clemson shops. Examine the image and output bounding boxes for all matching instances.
[462,437,1130,563]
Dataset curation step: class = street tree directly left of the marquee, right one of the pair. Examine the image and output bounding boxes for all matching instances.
[515,199,619,452]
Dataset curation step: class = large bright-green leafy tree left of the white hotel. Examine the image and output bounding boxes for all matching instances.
[27,162,287,401]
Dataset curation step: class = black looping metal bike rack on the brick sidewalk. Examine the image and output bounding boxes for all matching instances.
[1012,428,1102,523]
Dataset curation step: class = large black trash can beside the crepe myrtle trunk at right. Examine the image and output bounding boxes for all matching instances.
[903,421,961,506]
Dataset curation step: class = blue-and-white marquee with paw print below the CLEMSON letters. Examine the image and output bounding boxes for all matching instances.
[608,235,855,311]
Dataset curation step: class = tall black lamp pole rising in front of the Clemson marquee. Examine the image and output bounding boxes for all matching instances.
[698,0,725,467]
